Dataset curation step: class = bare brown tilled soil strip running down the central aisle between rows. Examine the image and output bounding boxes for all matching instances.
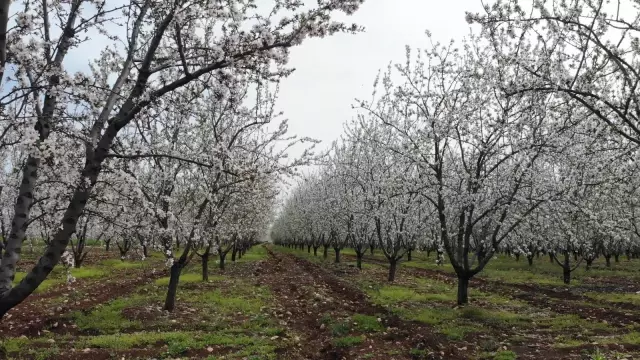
[259,250,468,360]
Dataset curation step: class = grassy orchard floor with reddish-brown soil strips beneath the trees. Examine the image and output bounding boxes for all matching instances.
[0,246,640,360]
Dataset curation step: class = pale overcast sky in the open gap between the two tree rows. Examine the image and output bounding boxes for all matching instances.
[278,0,482,159]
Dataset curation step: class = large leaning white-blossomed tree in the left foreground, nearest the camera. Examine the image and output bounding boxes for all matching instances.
[0,0,362,316]
